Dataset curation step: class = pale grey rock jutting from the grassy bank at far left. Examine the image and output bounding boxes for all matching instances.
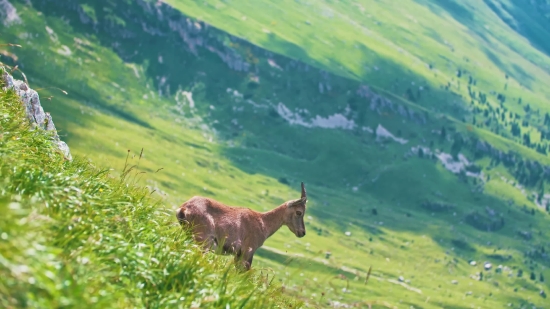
[0,67,73,161]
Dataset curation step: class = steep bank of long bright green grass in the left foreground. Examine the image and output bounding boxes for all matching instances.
[0,67,297,308]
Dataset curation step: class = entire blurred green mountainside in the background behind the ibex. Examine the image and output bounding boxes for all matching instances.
[0,0,550,308]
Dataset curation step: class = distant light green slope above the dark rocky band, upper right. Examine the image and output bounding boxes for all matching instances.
[166,0,550,149]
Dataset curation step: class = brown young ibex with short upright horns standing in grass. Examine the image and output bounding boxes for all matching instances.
[176,182,307,270]
